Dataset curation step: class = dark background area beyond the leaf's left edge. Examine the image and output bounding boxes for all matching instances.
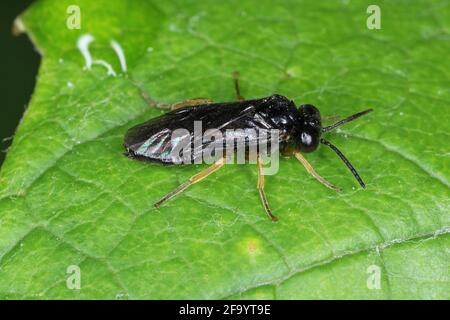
[0,0,41,165]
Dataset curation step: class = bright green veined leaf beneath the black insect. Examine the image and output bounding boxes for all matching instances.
[0,0,450,299]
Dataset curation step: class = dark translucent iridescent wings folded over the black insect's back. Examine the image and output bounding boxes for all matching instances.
[125,96,296,163]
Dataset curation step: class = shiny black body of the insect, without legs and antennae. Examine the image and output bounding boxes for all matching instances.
[124,95,322,164]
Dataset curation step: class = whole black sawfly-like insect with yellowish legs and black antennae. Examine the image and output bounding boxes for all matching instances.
[124,72,372,221]
